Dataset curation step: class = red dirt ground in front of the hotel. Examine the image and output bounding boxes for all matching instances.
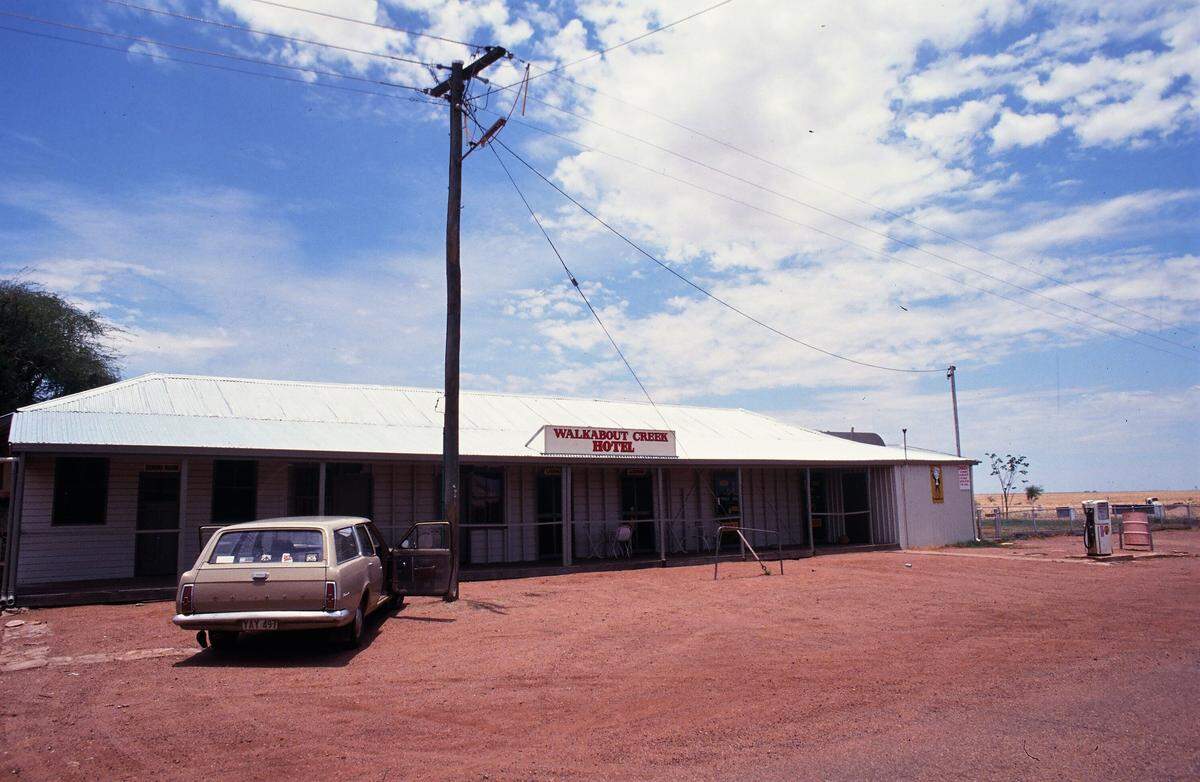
[0,533,1200,780]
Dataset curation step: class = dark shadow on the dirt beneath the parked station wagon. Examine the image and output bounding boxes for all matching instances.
[174,606,393,668]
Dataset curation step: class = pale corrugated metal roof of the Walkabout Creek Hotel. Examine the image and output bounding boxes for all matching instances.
[10,374,968,463]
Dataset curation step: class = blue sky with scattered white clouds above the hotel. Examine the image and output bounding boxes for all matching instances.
[0,0,1200,491]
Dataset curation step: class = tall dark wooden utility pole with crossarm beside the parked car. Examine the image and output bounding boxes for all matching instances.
[428,47,508,602]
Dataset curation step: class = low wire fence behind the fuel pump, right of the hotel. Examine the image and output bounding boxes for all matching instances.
[976,503,1200,542]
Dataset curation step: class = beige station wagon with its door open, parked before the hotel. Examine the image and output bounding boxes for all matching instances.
[172,516,457,651]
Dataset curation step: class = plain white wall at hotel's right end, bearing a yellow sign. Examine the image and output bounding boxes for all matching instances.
[895,464,974,548]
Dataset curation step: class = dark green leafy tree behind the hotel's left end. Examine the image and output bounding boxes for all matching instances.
[0,279,120,415]
